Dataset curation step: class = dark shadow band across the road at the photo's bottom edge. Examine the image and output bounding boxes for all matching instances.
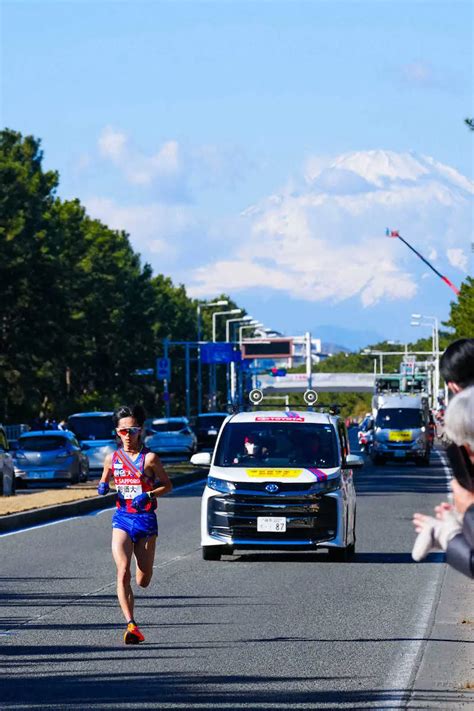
[2,672,466,711]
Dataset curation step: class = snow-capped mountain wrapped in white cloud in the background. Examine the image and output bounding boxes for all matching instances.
[192,150,474,306]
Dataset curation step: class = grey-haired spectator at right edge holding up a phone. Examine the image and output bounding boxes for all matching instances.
[412,381,474,578]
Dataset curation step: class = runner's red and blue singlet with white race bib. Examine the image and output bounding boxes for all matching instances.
[112,447,157,513]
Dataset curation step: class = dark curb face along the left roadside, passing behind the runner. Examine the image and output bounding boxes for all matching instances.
[0,470,206,534]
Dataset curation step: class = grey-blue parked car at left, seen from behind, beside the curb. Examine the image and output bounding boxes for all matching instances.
[13,430,89,487]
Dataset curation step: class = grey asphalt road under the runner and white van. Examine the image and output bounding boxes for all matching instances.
[0,434,460,711]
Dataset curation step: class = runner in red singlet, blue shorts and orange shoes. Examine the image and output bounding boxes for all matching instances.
[97,405,173,644]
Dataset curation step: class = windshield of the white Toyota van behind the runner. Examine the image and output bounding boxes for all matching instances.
[215,422,339,469]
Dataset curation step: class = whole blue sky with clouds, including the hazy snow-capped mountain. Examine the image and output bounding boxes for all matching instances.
[2,0,474,345]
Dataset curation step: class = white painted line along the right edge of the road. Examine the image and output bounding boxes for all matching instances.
[377,450,452,709]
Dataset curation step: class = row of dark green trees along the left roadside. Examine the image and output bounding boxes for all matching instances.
[0,129,245,422]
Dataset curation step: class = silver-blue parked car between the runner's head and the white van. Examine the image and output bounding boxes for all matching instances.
[145,417,197,457]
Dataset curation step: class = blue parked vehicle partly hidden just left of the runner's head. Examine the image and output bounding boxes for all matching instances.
[67,412,117,476]
